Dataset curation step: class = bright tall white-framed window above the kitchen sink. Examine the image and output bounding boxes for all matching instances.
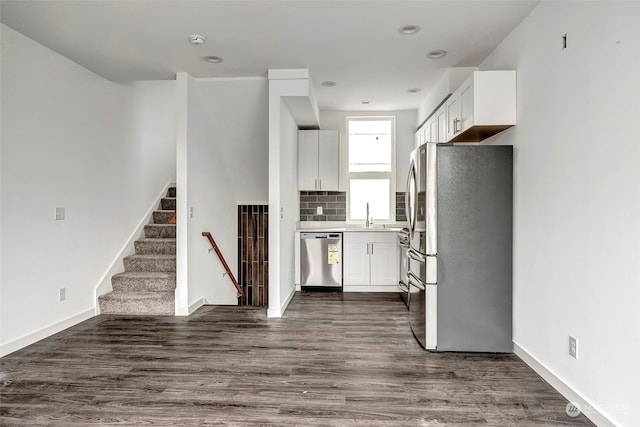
[347,117,396,223]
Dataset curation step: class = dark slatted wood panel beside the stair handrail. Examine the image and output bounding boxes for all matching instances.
[238,205,269,307]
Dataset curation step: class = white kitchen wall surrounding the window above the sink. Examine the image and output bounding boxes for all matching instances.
[320,110,418,192]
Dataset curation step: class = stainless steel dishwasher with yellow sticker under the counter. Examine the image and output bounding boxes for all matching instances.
[300,233,342,289]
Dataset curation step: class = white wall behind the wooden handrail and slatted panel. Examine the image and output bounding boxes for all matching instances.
[178,77,269,314]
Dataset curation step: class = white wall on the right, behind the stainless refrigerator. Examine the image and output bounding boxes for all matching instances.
[481,2,640,427]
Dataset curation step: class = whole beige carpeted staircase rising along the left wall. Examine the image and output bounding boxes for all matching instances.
[98,187,176,315]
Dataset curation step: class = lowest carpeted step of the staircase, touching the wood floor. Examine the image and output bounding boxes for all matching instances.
[98,292,175,316]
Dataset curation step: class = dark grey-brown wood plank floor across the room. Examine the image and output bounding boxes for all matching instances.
[0,293,592,426]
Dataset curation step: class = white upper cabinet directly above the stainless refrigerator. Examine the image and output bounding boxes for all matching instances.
[445,70,516,142]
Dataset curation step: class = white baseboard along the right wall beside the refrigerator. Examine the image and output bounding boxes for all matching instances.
[513,342,615,427]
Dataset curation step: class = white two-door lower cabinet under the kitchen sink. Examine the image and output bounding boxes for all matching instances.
[342,231,398,292]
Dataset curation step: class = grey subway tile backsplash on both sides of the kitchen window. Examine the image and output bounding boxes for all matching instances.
[300,191,407,222]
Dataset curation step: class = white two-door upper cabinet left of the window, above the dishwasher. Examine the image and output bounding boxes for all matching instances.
[298,130,340,191]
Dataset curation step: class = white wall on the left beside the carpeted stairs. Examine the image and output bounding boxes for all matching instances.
[0,25,175,354]
